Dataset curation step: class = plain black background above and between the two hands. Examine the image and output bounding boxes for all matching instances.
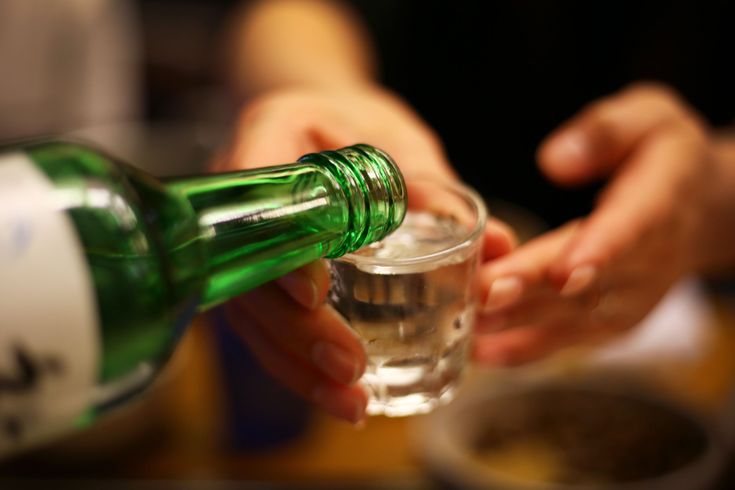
[355,0,735,226]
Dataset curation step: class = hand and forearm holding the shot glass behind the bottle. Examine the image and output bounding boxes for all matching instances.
[212,0,514,423]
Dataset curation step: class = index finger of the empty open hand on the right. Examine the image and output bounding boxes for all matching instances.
[550,119,705,294]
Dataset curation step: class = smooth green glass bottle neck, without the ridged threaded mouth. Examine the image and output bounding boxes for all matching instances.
[167,164,352,309]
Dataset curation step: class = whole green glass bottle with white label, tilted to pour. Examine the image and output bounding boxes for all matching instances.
[0,141,406,455]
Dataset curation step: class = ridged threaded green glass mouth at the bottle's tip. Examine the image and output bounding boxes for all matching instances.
[299,144,407,258]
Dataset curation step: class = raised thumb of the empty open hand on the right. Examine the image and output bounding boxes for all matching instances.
[537,83,691,186]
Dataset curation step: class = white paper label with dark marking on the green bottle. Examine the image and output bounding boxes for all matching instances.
[0,153,100,455]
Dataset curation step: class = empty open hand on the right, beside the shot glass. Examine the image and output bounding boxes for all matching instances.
[475,84,735,364]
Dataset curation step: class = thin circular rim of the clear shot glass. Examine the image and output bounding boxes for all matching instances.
[332,176,489,268]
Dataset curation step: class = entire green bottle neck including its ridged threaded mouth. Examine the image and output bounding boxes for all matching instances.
[167,145,406,309]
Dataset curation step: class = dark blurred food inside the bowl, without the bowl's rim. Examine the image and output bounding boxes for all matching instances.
[470,389,708,485]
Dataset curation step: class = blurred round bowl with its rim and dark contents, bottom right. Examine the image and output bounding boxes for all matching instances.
[411,373,726,490]
